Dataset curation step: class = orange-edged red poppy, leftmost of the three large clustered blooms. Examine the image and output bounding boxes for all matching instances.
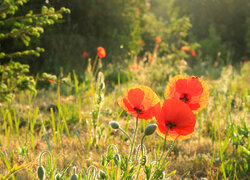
[118,86,160,120]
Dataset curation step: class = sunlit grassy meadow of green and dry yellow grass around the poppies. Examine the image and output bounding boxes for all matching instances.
[0,53,250,179]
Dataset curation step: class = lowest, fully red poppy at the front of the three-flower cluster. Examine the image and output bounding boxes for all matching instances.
[156,99,196,140]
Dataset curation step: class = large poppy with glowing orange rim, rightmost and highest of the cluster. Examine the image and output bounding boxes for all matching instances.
[165,75,209,112]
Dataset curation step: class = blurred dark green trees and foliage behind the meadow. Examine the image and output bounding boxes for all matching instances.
[0,0,250,74]
